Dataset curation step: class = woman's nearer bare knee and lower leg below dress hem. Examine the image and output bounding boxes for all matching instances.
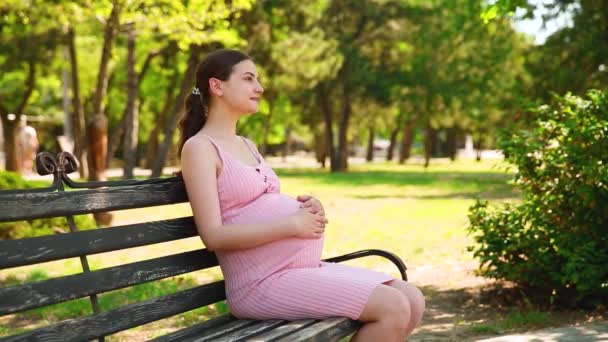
[351,284,411,342]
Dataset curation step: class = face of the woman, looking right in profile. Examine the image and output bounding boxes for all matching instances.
[221,60,264,114]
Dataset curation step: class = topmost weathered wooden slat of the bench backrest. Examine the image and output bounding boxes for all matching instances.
[0,178,188,222]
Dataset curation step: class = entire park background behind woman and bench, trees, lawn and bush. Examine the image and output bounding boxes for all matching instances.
[0,0,608,341]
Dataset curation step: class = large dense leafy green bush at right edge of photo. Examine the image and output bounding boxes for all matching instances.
[469,91,608,300]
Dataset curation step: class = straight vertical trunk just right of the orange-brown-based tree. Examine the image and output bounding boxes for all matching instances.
[123,25,139,179]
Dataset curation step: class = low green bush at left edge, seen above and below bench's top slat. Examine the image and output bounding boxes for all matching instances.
[0,172,96,240]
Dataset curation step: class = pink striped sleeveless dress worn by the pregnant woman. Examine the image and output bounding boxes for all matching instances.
[201,135,394,320]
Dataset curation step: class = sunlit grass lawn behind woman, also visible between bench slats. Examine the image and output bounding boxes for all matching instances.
[0,161,518,340]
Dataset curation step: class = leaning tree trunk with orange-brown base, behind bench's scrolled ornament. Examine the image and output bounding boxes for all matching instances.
[88,2,121,183]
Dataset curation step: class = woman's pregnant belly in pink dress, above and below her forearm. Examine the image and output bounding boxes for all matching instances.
[216,193,324,295]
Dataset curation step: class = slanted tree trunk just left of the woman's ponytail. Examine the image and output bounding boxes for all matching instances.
[151,45,203,177]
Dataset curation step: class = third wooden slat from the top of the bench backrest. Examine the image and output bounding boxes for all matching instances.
[0,249,218,315]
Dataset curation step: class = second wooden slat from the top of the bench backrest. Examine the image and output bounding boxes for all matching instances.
[0,217,198,269]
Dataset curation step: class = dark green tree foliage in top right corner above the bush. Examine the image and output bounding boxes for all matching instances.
[482,0,608,97]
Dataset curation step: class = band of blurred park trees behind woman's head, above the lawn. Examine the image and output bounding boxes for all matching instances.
[0,0,607,179]
